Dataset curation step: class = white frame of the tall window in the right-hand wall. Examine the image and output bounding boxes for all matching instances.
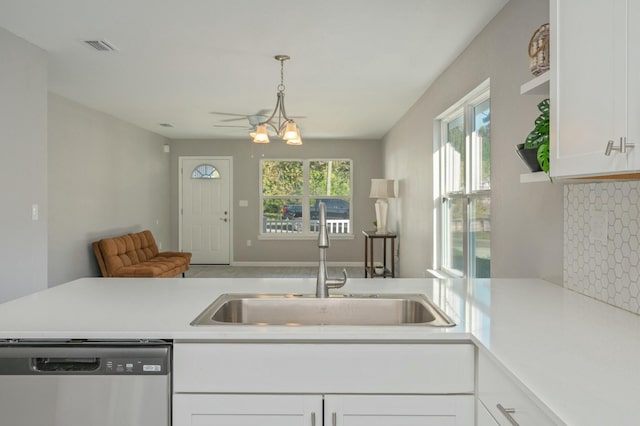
[433,79,491,278]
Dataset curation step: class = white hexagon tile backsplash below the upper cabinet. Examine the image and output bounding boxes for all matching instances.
[564,182,640,314]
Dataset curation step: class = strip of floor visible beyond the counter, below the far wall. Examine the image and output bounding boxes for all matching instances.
[185,265,364,278]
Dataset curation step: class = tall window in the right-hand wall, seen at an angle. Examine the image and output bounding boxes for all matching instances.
[434,81,491,278]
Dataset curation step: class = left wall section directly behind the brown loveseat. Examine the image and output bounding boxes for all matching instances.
[48,94,171,286]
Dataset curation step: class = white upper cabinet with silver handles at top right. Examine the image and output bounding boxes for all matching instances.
[550,0,640,177]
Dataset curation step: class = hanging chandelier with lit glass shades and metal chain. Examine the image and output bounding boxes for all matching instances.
[250,55,302,145]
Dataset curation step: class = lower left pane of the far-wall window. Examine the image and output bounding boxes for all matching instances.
[262,198,302,234]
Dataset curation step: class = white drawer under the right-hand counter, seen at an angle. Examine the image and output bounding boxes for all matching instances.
[478,351,564,426]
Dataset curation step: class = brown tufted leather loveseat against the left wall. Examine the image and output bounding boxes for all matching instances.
[91,230,191,277]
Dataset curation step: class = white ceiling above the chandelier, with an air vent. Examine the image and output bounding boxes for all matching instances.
[0,0,508,139]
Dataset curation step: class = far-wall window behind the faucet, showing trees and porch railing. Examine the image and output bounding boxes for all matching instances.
[260,160,352,238]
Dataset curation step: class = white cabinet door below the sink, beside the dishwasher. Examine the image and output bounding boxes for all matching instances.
[173,394,322,426]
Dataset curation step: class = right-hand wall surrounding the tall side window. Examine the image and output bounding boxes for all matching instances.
[384,0,563,283]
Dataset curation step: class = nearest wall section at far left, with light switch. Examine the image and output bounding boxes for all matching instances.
[0,28,47,302]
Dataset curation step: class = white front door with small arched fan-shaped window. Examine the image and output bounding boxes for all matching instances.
[180,157,232,265]
